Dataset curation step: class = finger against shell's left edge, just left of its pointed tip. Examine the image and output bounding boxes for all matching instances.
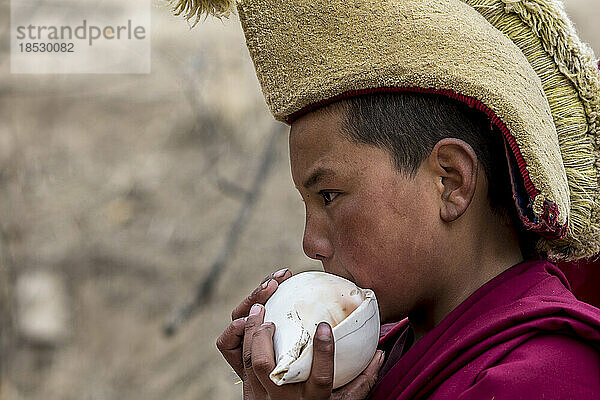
[252,322,279,393]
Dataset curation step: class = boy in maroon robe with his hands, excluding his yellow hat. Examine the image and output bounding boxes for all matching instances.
[217,94,600,399]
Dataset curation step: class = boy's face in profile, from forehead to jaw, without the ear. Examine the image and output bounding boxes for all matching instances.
[290,105,444,322]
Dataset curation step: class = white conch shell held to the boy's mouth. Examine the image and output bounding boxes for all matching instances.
[265,271,379,389]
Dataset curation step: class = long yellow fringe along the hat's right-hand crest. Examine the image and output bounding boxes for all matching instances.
[472,0,600,260]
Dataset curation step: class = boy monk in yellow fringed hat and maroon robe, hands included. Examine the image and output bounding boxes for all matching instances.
[166,0,600,400]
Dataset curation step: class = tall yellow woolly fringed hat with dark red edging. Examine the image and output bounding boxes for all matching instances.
[171,0,600,260]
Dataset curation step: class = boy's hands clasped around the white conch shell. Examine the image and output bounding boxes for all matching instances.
[217,268,384,400]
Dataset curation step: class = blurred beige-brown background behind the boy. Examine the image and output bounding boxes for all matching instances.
[0,0,600,400]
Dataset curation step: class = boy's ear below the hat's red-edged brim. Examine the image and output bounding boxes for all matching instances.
[428,138,478,222]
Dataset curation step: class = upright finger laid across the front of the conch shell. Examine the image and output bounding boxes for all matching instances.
[305,322,335,399]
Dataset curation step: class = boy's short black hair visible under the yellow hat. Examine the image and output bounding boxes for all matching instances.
[334,92,537,255]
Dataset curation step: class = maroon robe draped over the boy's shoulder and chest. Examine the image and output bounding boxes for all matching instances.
[370,260,600,400]
